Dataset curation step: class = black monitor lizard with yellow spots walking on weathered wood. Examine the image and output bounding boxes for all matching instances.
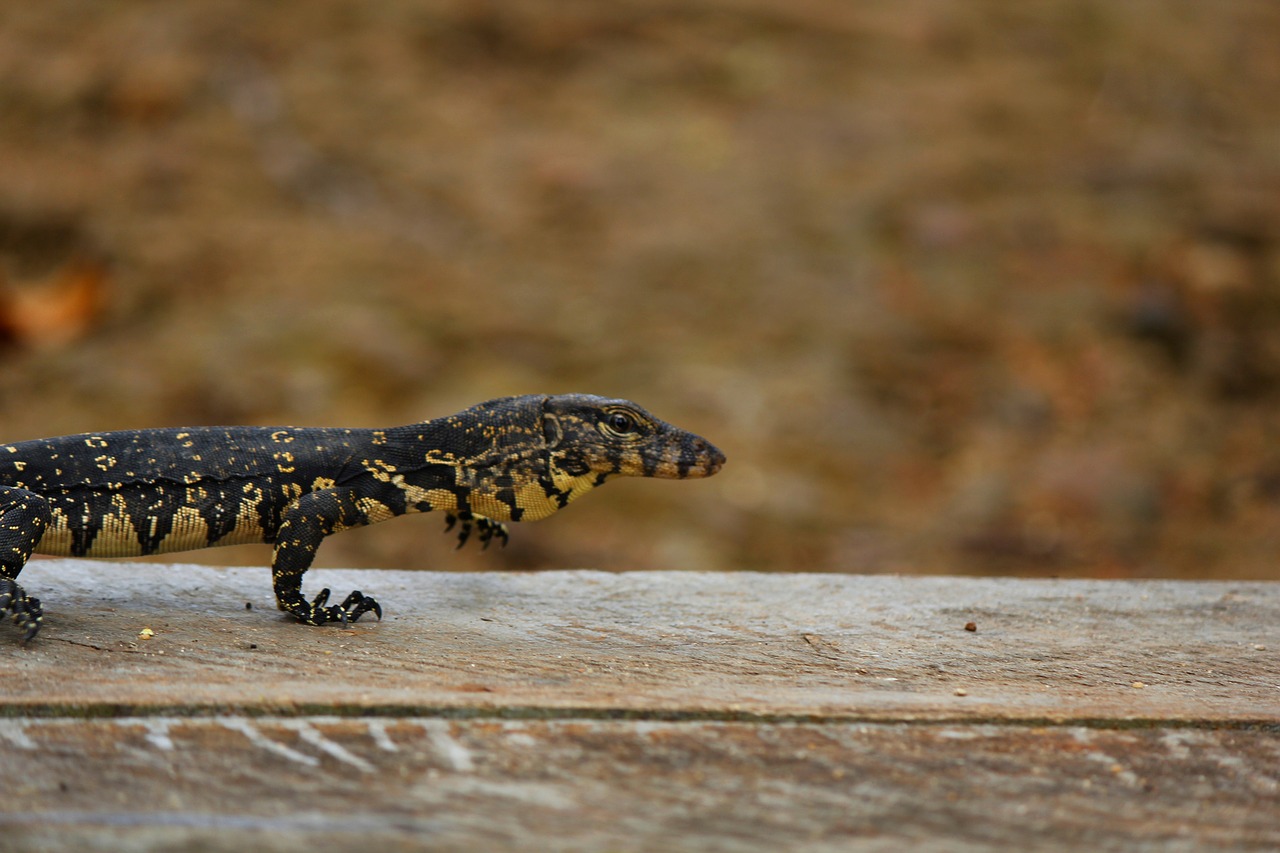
[0,394,724,640]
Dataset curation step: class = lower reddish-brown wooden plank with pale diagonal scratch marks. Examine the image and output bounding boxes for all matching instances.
[0,717,1280,853]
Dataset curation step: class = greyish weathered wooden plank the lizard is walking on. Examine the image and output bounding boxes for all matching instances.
[0,560,1280,722]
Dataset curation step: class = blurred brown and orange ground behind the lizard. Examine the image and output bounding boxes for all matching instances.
[0,0,1280,578]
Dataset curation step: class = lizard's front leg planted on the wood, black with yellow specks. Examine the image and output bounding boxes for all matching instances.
[271,489,383,625]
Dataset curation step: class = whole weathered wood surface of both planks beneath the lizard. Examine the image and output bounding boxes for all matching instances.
[0,561,1280,850]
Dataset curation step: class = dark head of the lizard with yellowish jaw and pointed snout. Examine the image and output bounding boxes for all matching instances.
[543,394,724,497]
